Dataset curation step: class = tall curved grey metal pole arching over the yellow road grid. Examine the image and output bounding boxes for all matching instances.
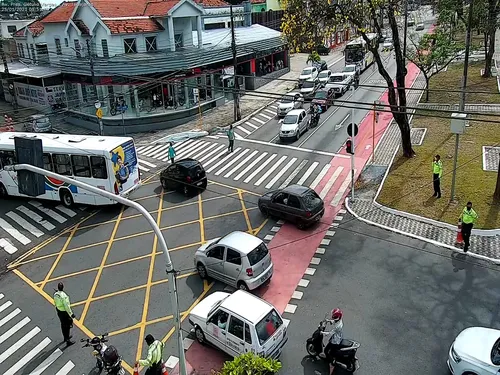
[4,164,187,375]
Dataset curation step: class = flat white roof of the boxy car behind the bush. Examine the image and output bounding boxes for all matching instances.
[221,290,274,324]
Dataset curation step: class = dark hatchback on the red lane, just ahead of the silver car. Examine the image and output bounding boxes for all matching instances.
[258,185,325,229]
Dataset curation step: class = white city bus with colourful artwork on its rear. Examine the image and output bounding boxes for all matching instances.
[0,132,141,207]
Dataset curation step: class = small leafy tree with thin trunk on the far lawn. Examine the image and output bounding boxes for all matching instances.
[406,28,464,102]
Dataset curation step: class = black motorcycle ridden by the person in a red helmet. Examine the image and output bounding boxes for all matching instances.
[306,317,360,373]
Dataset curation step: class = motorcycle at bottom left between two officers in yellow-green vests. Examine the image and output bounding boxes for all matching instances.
[80,333,125,375]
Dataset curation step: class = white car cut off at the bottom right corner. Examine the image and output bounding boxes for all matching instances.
[447,327,500,375]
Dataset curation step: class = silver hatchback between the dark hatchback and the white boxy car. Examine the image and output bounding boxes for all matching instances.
[194,231,273,290]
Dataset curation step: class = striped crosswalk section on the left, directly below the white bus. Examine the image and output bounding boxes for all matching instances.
[0,200,85,255]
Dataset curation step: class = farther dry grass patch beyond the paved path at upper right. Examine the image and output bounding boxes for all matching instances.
[422,61,500,104]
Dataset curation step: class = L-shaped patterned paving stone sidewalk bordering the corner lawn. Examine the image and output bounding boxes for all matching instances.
[346,74,500,260]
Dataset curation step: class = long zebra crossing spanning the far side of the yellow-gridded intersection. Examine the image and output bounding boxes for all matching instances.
[137,137,351,206]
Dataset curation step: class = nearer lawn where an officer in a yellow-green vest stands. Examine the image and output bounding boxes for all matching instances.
[378,111,500,229]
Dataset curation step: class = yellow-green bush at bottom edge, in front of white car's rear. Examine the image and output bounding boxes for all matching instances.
[217,353,281,375]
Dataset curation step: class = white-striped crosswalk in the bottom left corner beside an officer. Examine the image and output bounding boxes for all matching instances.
[0,293,75,375]
